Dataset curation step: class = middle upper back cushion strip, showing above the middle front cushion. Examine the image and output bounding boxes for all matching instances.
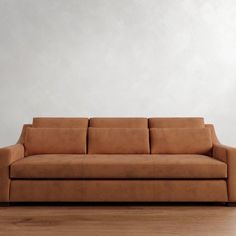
[89,117,148,128]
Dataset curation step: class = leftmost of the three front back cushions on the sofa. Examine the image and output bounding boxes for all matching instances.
[25,128,87,156]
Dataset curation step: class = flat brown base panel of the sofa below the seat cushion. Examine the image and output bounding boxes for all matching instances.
[10,180,227,202]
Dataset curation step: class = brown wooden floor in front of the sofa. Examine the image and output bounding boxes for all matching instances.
[0,205,236,236]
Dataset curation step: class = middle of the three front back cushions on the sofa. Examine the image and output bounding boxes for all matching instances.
[88,128,150,154]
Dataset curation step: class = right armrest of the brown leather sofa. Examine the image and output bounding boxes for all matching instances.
[213,144,236,202]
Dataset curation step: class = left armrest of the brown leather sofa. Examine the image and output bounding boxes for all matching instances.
[0,144,24,202]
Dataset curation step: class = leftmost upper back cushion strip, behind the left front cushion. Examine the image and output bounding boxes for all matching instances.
[33,117,88,128]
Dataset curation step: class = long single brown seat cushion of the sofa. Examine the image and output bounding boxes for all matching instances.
[10,154,227,179]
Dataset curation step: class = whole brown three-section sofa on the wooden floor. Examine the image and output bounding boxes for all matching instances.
[0,117,236,203]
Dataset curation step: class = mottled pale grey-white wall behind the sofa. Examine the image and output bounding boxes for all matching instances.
[0,0,236,146]
